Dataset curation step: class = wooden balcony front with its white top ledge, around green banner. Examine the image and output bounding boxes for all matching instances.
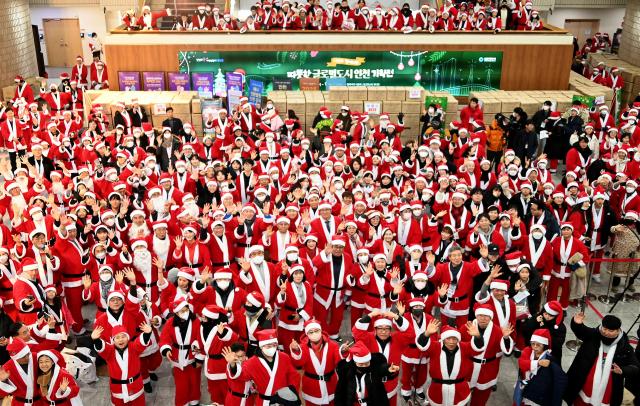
[104,29,573,90]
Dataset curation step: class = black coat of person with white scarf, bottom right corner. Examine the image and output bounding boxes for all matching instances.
[564,319,640,406]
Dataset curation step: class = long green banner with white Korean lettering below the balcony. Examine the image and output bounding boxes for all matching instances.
[178,51,502,96]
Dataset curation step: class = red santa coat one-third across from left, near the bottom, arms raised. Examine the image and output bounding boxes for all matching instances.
[197,324,239,381]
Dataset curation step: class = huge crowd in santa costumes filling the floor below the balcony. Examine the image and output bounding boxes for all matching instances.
[0,54,640,406]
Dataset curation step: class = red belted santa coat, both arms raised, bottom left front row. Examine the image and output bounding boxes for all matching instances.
[98,332,149,403]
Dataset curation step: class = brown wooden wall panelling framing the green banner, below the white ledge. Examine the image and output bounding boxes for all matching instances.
[104,42,573,90]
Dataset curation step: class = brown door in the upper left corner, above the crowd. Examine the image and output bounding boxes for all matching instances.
[42,18,82,68]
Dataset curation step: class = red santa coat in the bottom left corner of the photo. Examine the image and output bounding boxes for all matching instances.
[0,352,40,406]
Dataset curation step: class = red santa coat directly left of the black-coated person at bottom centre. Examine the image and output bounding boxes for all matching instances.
[291,333,342,405]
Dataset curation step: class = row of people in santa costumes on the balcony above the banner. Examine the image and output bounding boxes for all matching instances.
[122,0,544,33]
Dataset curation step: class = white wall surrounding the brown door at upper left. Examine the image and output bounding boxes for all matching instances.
[31,6,107,65]
